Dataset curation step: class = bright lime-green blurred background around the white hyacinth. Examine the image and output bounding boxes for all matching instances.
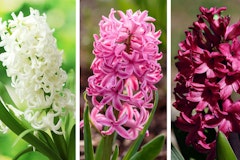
[0,0,76,160]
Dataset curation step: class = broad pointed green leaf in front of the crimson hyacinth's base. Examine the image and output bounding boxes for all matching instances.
[217,132,237,160]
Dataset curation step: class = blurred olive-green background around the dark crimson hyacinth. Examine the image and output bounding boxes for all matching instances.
[171,0,240,159]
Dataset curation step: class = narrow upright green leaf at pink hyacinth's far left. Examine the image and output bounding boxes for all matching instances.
[83,106,94,160]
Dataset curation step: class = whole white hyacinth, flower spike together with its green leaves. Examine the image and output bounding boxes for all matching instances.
[0,8,75,159]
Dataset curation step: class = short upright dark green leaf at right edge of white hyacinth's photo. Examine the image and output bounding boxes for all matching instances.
[67,125,76,160]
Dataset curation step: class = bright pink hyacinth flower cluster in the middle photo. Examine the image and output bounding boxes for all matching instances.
[87,9,162,140]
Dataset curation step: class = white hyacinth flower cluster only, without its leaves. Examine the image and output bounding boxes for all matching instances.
[0,8,74,134]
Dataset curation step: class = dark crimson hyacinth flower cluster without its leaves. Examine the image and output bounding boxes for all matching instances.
[173,7,240,159]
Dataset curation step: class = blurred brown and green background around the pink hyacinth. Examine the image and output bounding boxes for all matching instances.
[80,0,167,160]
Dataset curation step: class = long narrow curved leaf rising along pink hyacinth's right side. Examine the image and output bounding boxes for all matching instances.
[123,91,158,160]
